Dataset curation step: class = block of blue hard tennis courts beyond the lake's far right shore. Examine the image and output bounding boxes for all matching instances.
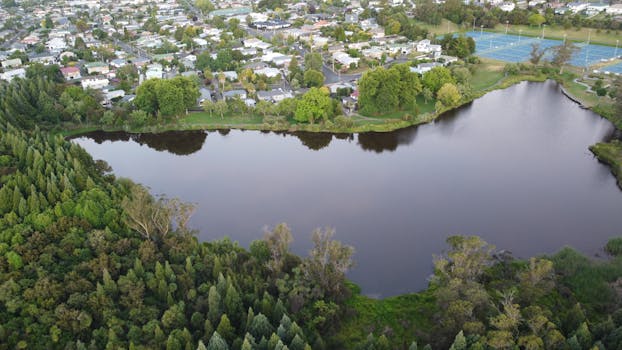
[466,31,622,67]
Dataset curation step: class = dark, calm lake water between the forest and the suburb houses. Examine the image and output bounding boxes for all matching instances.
[74,82,622,297]
